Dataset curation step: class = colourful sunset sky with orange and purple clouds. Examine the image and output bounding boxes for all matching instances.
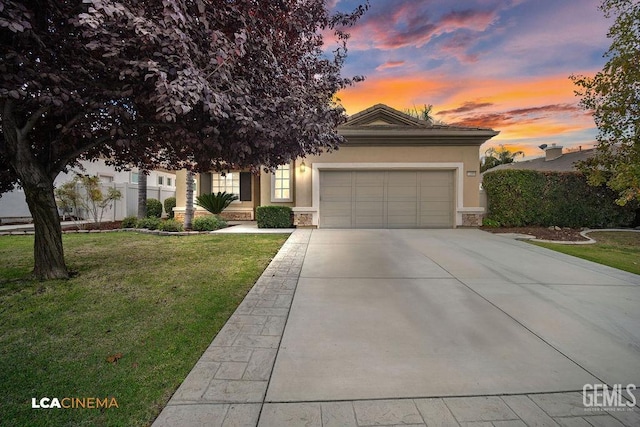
[330,0,611,156]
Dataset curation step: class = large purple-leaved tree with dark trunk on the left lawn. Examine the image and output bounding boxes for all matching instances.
[0,0,368,279]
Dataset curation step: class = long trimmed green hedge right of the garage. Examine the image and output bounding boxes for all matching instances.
[482,170,637,228]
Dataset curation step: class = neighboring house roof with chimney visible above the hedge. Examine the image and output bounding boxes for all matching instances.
[485,144,595,173]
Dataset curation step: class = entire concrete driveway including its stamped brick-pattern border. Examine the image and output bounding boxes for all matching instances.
[154,230,640,426]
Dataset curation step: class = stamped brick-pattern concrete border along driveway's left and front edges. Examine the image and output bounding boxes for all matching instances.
[153,230,640,427]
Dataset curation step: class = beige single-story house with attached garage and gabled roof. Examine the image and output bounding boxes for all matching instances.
[175,104,498,228]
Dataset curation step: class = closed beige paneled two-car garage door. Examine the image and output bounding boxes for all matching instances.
[320,170,454,228]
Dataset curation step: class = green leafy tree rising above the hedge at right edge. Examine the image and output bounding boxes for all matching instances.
[571,0,640,205]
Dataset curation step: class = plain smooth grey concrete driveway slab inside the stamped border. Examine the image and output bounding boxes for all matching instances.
[265,230,640,402]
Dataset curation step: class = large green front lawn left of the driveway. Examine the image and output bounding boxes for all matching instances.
[0,233,285,426]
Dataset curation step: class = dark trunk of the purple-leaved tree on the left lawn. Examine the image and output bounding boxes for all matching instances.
[22,174,69,280]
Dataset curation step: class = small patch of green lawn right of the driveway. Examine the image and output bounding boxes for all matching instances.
[532,231,640,274]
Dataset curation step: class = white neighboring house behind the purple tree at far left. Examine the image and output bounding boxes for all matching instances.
[0,159,176,223]
